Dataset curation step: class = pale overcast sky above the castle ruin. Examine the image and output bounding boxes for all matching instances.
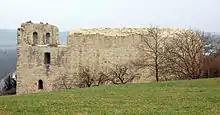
[0,0,220,32]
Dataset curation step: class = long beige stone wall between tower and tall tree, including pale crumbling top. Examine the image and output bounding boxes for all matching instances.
[67,28,154,82]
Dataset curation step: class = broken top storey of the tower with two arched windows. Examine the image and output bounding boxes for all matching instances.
[18,21,59,46]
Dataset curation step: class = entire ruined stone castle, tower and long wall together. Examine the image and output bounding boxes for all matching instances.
[16,22,198,94]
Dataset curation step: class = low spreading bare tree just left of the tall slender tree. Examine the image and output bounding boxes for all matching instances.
[109,64,140,84]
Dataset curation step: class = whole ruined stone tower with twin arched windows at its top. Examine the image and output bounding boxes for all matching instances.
[16,21,64,94]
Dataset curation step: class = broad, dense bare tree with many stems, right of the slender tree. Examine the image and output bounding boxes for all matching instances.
[165,30,204,79]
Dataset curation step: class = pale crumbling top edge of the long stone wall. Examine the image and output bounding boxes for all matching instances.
[67,27,191,46]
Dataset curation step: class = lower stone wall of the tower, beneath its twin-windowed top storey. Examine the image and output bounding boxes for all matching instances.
[17,46,66,93]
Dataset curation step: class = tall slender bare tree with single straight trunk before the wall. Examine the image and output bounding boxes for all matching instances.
[134,27,166,82]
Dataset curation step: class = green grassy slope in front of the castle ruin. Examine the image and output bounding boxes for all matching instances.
[0,79,220,115]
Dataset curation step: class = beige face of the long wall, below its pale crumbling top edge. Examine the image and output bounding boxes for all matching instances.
[67,33,144,82]
